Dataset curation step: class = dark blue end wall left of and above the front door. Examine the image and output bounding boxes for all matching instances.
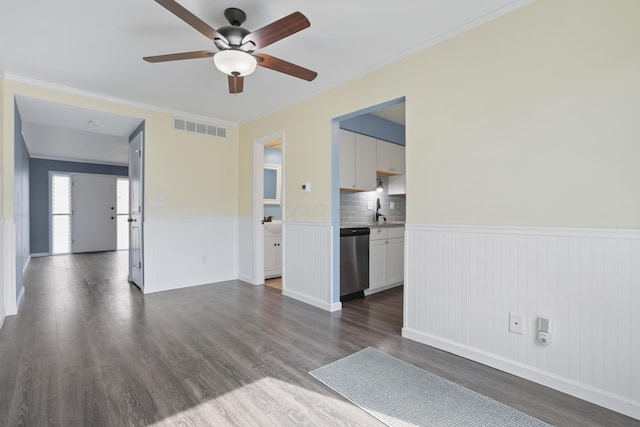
[29,159,129,254]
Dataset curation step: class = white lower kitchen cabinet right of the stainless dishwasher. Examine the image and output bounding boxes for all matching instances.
[366,226,404,294]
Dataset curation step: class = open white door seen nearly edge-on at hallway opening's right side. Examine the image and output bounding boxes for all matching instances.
[129,132,144,289]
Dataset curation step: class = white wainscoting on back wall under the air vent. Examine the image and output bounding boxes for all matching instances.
[144,218,238,293]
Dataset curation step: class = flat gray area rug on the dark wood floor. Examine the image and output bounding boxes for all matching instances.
[309,347,549,427]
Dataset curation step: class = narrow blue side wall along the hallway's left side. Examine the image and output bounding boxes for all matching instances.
[13,101,31,302]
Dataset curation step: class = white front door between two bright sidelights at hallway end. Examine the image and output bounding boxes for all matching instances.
[71,175,117,253]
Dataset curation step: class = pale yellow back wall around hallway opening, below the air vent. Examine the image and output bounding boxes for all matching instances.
[3,80,238,219]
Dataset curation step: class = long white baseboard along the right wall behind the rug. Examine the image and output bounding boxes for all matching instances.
[402,328,640,419]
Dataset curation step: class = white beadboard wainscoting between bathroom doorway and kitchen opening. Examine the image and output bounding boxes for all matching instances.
[282,221,342,311]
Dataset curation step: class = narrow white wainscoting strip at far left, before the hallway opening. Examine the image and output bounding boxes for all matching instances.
[0,218,18,319]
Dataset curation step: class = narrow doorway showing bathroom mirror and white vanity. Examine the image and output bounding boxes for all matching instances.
[253,132,286,291]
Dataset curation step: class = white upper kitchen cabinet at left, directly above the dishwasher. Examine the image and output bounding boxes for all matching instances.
[340,129,377,191]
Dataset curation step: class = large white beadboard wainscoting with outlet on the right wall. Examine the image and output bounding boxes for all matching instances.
[402,225,640,418]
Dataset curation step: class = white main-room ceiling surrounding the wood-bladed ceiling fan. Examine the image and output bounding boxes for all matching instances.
[0,0,532,164]
